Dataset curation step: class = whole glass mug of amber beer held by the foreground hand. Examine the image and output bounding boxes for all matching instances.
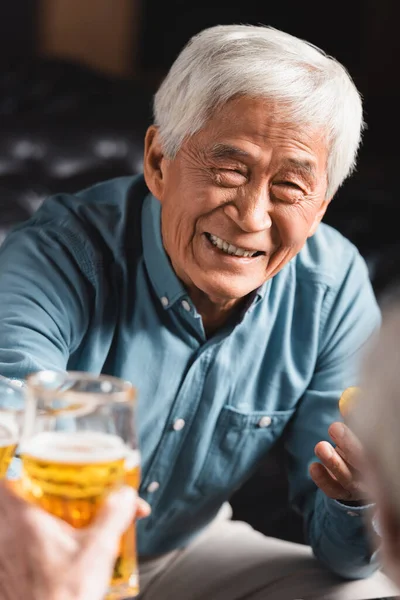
[20,371,144,600]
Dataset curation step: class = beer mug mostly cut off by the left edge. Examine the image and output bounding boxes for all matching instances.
[0,376,25,479]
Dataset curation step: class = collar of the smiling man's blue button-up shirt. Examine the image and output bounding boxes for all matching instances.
[142,194,270,316]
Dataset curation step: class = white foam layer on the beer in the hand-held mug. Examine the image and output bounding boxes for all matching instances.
[21,431,140,468]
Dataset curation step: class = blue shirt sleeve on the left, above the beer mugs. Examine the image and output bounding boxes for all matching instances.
[0,220,93,380]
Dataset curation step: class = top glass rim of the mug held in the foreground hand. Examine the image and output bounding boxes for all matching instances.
[25,369,137,404]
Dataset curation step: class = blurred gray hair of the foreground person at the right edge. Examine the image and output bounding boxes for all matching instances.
[348,300,400,520]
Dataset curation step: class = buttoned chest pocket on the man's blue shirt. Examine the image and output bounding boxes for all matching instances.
[196,406,295,495]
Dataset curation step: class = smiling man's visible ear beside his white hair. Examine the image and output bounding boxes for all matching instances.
[143,125,166,201]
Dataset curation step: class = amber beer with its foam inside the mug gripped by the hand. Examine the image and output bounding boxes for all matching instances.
[21,431,140,600]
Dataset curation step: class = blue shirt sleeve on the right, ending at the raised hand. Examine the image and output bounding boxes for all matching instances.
[286,253,381,579]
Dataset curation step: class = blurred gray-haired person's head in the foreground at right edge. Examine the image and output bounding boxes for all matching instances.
[347,294,400,587]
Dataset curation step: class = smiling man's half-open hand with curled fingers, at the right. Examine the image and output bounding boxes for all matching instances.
[310,422,367,503]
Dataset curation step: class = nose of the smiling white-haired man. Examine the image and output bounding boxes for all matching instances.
[224,186,272,233]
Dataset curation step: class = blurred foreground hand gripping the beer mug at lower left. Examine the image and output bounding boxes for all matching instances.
[0,482,149,600]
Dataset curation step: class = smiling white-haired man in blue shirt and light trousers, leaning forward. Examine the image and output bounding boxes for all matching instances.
[0,25,395,600]
